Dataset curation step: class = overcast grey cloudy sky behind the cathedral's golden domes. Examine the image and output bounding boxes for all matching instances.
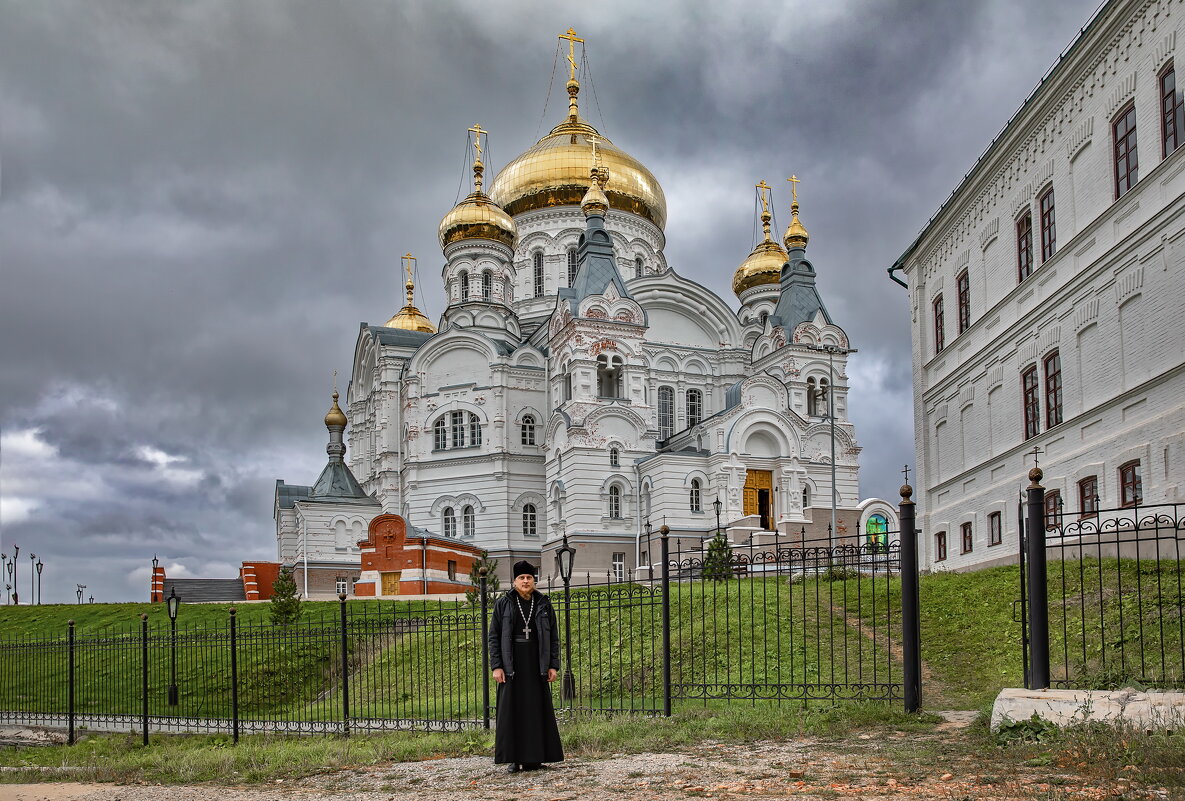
[0,0,1096,602]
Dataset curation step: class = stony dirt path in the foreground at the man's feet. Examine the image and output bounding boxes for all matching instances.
[0,730,1137,801]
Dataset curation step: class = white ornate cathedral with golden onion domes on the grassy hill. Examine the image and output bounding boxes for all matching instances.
[275,31,895,595]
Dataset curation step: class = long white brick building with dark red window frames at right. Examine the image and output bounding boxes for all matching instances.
[890,0,1185,569]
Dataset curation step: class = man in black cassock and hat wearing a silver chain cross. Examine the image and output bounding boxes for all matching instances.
[489,562,564,773]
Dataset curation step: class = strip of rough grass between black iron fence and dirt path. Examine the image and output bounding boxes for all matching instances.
[0,704,936,784]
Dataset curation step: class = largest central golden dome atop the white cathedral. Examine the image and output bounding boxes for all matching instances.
[489,115,666,229]
